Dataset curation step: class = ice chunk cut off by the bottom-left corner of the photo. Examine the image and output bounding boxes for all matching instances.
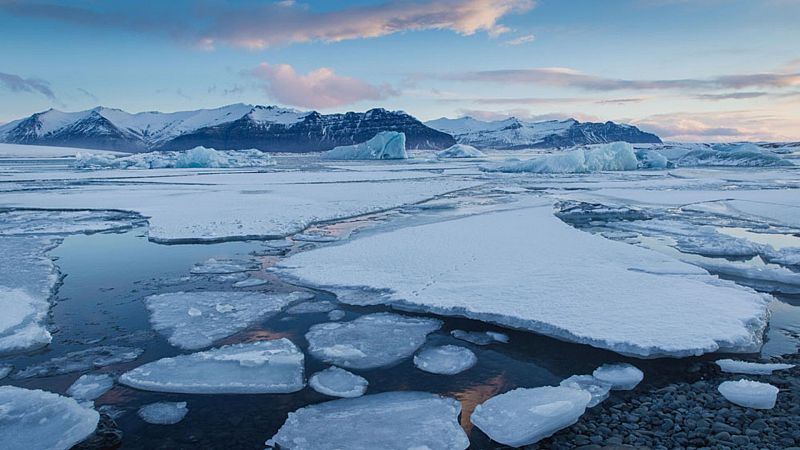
[0,386,100,450]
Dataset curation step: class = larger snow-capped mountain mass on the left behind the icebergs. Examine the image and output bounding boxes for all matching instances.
[0,104,455,152]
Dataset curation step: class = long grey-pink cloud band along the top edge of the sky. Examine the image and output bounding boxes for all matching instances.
[0,0,535,49]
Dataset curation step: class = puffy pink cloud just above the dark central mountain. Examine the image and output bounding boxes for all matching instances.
[249,63,397,108]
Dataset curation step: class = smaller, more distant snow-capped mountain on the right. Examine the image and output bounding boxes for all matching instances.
[425,117,661,150]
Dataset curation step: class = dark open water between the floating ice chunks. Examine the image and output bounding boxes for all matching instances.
[0,226,736,449]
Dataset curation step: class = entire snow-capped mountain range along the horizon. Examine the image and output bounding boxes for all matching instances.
[0,103,661,152]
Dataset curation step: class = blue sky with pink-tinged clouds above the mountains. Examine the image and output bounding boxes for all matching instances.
[0,0,800,142]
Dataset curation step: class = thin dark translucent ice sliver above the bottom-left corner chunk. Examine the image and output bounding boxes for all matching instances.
[14,345,144,378]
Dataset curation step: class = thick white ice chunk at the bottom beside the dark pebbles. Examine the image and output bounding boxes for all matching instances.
[470,386,592,447]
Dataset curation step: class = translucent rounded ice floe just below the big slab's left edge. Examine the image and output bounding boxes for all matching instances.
[306,313,442,369]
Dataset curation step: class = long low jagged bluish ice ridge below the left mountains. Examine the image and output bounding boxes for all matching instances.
[73,147,275,169]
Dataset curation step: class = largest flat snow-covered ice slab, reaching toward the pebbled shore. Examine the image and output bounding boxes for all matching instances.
[274,202,769,357]
